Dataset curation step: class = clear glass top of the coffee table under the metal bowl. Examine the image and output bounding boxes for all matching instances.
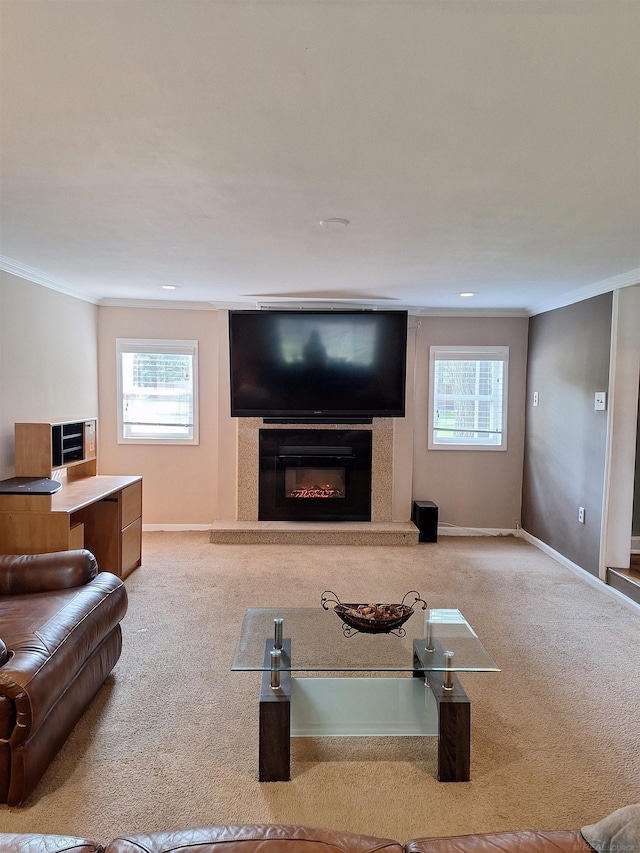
[231,607,500,672]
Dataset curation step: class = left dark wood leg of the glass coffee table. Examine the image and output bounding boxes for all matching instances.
[258,639,291,782]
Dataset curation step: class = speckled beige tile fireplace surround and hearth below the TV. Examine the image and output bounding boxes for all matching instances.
[210,418,418,545]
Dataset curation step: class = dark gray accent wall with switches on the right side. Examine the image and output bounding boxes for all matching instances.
[522,293,612,576]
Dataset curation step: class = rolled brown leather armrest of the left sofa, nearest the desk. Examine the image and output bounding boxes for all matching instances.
[0,548,98,595]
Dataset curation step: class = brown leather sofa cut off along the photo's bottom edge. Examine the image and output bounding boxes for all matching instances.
[0,824,600,853]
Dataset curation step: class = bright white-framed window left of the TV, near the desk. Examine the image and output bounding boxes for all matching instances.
[116,338,198,444]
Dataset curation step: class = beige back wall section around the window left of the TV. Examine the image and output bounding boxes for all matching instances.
[98,306,220,526]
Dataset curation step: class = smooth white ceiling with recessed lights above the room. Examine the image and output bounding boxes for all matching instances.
[0,0,640,313]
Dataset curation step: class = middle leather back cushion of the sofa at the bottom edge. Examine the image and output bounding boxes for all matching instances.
[105,824,403,853]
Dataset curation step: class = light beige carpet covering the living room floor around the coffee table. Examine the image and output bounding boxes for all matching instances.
[0,533,640,841]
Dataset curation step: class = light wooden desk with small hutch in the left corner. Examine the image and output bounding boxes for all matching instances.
[0,419,142,578]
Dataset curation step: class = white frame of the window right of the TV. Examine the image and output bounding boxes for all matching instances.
[427,346,509,451]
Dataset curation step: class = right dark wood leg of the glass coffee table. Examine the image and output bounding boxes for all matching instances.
[413,640,471,782]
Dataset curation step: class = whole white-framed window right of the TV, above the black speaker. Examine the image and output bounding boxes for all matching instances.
[429,346,509,450]
